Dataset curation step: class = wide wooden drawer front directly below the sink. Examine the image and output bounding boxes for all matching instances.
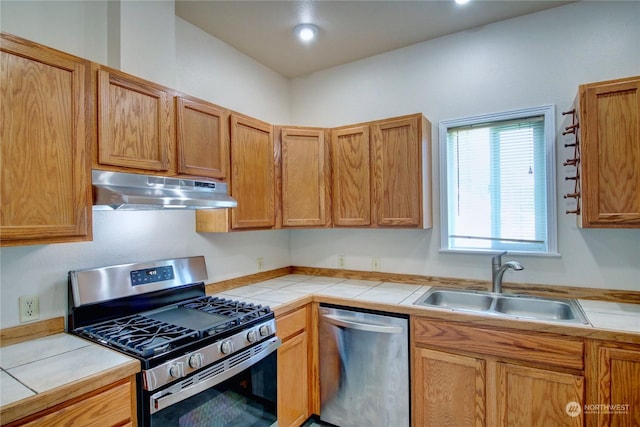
[413,318,584,370]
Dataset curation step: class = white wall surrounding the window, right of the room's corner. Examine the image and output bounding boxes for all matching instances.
[291,1,640,291]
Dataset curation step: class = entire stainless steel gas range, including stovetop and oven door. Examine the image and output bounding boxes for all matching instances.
[67,256,281,427]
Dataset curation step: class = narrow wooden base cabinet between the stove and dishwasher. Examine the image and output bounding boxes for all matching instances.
[276,306,314,427]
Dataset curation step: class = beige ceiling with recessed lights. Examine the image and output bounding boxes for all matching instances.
[175,0,571,78]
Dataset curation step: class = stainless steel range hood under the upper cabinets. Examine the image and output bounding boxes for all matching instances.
[92,170,238,210]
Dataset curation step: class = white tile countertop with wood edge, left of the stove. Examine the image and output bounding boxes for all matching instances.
[0,333,140,424]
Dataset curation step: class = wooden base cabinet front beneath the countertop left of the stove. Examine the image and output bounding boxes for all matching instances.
[7,376,137,427]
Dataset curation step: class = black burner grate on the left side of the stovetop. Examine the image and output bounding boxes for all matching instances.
[80,315,199,357]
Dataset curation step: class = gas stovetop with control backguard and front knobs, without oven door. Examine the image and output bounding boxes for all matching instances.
[67,256,276,390]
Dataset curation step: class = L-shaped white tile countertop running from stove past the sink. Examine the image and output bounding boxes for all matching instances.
[214,274,640,342]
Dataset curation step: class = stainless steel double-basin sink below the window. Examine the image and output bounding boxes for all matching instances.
[414,288,589,324]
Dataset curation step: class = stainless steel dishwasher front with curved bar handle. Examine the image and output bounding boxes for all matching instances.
[319,306,410,427]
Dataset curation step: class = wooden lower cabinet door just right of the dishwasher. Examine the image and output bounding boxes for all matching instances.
[413,348,486,427]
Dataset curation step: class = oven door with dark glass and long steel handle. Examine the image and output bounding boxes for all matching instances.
[149,337,281,427]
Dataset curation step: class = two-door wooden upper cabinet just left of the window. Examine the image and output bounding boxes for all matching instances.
[331,114,432,228]
